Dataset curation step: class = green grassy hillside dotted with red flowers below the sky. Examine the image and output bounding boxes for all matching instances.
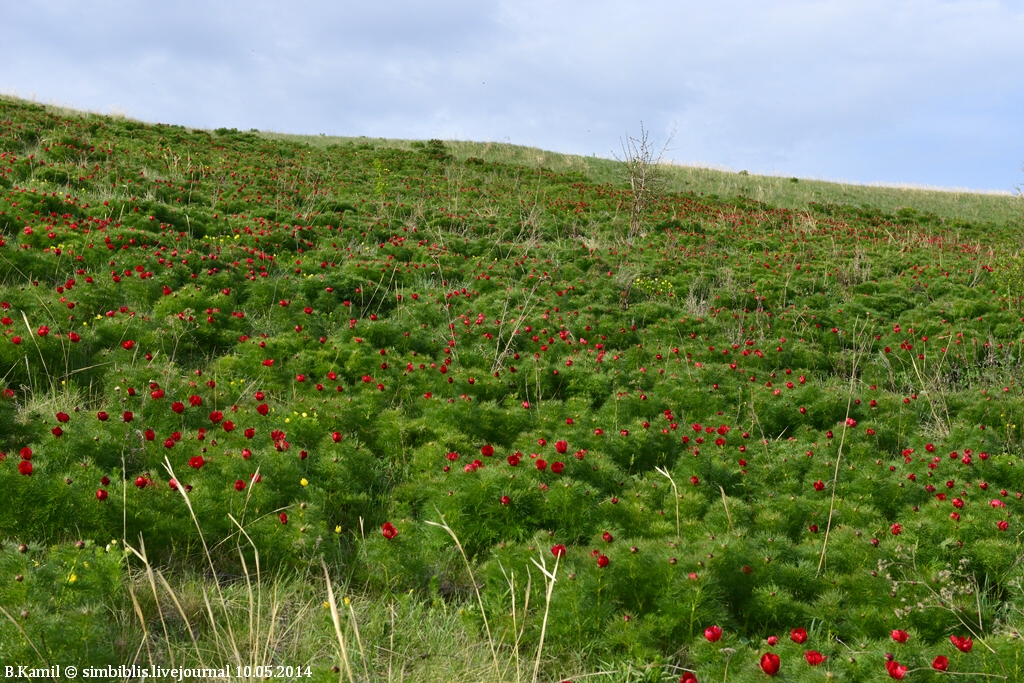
[0,98,1024,681]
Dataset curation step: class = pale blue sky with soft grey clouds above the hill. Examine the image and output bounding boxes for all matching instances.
[0,0,1024,190]
